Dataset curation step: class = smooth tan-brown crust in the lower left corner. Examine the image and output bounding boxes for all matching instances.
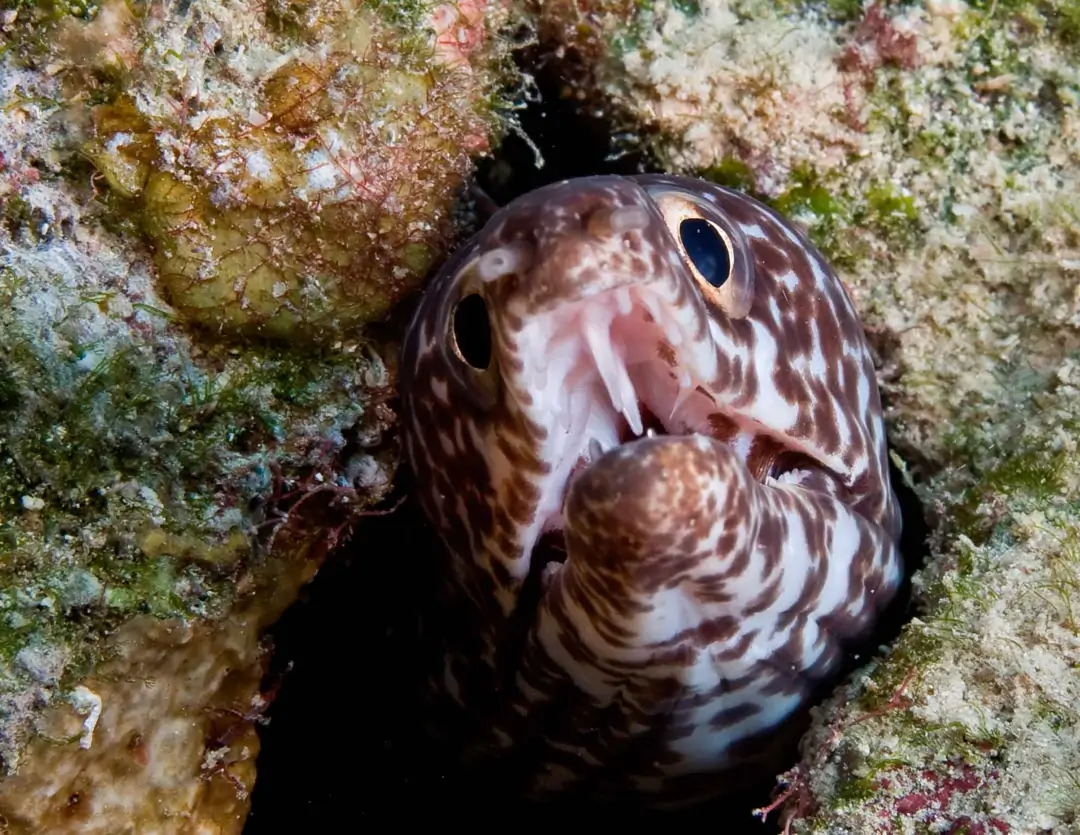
[0,617,261,835]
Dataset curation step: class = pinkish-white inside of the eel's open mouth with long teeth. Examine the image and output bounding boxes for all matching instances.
[522,287,725,587]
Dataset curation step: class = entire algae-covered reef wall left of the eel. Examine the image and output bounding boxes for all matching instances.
[0,0,511,835]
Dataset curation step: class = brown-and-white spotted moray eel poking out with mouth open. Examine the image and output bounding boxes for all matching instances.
[400,175,902,805]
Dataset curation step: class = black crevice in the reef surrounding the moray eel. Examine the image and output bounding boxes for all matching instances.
[244,52,928,835]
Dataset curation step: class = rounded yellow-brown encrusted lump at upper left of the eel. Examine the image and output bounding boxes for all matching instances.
[60,0,514,339]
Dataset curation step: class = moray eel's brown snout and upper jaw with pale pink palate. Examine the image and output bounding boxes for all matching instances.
[475,178,718,537]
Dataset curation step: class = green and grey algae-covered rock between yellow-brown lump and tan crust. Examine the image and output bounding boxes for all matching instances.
[0,241,392,769]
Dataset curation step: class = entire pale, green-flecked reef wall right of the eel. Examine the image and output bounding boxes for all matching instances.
[541,0,1080,833]
